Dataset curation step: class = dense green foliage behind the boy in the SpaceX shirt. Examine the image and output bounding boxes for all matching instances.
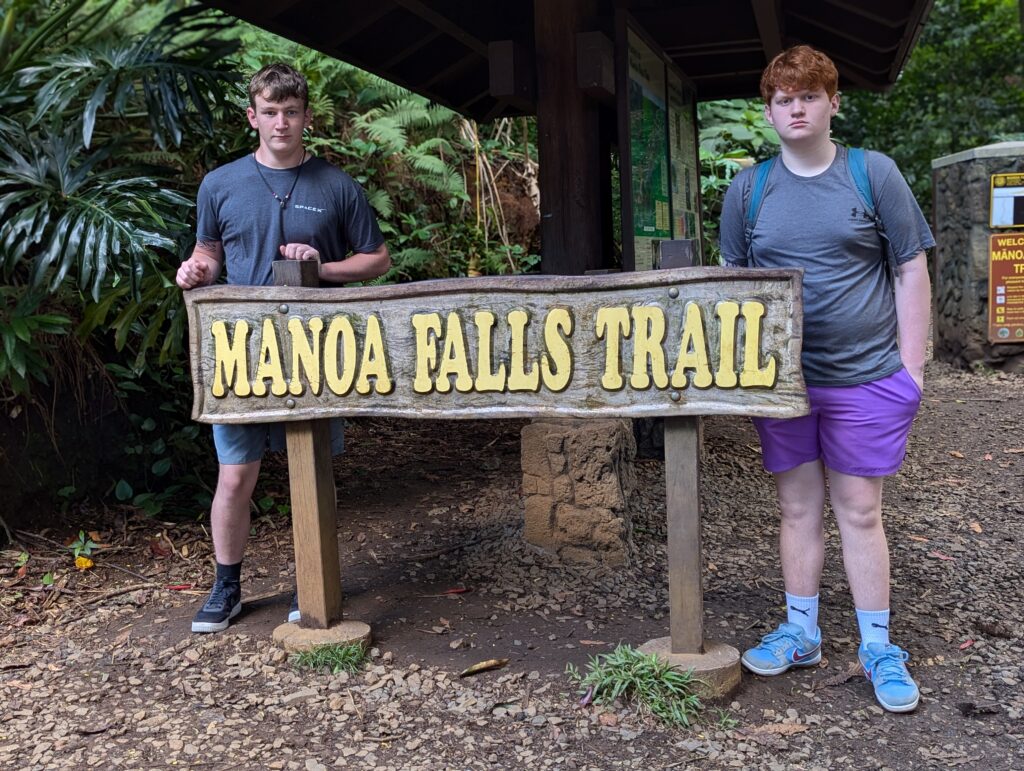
[0,0,538,520]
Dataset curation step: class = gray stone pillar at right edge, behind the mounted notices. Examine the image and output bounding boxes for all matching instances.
[932,142,1024,372]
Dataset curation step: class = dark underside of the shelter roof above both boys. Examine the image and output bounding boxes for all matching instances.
[206,0,933,120]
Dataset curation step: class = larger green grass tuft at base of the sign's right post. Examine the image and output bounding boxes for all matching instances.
[565,645,703,727]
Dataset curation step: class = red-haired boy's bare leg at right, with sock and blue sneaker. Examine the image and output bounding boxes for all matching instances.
[828,469,921,712]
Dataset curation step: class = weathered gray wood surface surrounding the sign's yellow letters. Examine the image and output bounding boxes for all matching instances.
[185,267,807,423]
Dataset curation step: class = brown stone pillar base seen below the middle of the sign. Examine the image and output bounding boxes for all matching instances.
[522,420,636,565]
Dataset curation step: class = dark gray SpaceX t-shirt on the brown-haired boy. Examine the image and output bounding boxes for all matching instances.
[196,155,384,287]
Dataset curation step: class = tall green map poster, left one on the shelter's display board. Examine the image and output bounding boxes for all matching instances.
[628,30,672,270]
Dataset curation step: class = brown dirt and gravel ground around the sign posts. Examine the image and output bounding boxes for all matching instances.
[0,363,1024,771]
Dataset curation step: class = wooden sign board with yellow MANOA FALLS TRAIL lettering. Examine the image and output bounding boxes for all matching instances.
[186,268,807,423]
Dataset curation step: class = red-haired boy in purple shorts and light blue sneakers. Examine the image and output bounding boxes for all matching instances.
[722,46,935,712]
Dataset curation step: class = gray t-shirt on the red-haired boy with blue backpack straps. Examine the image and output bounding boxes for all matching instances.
[721,145,935,386]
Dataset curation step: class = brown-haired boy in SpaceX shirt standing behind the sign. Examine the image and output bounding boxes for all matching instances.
[177,63,391,632]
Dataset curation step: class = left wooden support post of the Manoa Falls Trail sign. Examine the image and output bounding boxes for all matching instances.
[273,260,342,629]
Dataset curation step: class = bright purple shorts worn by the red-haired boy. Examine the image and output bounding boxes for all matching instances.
[754,369,922,476]
